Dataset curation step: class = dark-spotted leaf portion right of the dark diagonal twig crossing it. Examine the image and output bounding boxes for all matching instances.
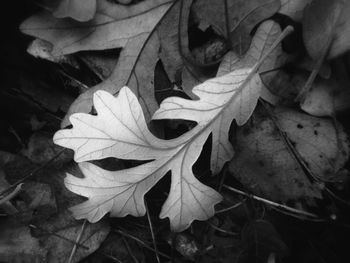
[276,107,349,181]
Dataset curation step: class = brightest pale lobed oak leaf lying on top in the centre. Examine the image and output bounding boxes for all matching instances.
[54,57,262,231]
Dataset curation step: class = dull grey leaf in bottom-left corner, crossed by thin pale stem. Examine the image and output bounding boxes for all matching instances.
[0,216,109,263]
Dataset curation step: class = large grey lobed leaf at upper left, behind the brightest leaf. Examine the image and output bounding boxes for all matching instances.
[21,0,172,127]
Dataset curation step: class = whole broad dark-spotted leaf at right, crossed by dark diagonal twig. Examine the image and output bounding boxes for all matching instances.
[229,108,349,202]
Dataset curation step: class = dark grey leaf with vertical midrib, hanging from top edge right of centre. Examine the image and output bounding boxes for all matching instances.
[192,0,280,55]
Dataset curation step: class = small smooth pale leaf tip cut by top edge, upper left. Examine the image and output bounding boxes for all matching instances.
[53,0,97,22]
